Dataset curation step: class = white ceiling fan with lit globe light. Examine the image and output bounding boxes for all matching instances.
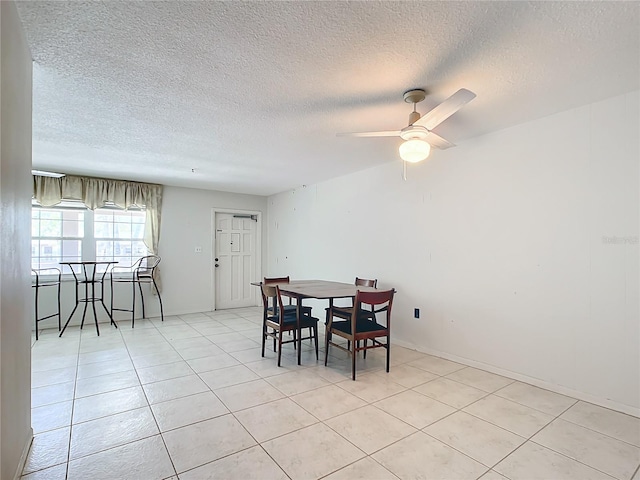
[338,88,476,180]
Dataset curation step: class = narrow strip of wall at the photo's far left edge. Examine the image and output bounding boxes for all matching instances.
[0,1,33,480]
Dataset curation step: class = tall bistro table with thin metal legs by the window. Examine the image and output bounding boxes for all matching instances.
[59,261,118,337]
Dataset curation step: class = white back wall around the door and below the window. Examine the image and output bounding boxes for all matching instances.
[35,186,267,329]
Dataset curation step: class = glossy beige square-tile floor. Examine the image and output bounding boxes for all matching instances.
[22,308,640,480]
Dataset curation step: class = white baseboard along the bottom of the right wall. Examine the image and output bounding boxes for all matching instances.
[394,340,640,417]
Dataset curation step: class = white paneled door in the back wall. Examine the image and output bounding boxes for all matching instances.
[214,212,257,310]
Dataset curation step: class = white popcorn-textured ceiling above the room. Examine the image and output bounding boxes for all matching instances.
[17,1,640,195]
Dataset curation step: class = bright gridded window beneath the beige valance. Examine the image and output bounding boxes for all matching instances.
[31,202,149,274]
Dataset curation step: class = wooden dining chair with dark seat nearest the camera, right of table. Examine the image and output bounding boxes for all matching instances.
[324,289,395,380]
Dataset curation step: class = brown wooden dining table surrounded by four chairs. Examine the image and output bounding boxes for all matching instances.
[251,280,377,365]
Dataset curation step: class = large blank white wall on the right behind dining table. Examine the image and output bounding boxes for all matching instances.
[268,92,640,414]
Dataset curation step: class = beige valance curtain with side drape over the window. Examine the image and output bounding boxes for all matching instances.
[33,175,162,255]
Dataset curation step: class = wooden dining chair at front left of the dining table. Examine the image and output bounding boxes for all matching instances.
[261,283,318,366]
